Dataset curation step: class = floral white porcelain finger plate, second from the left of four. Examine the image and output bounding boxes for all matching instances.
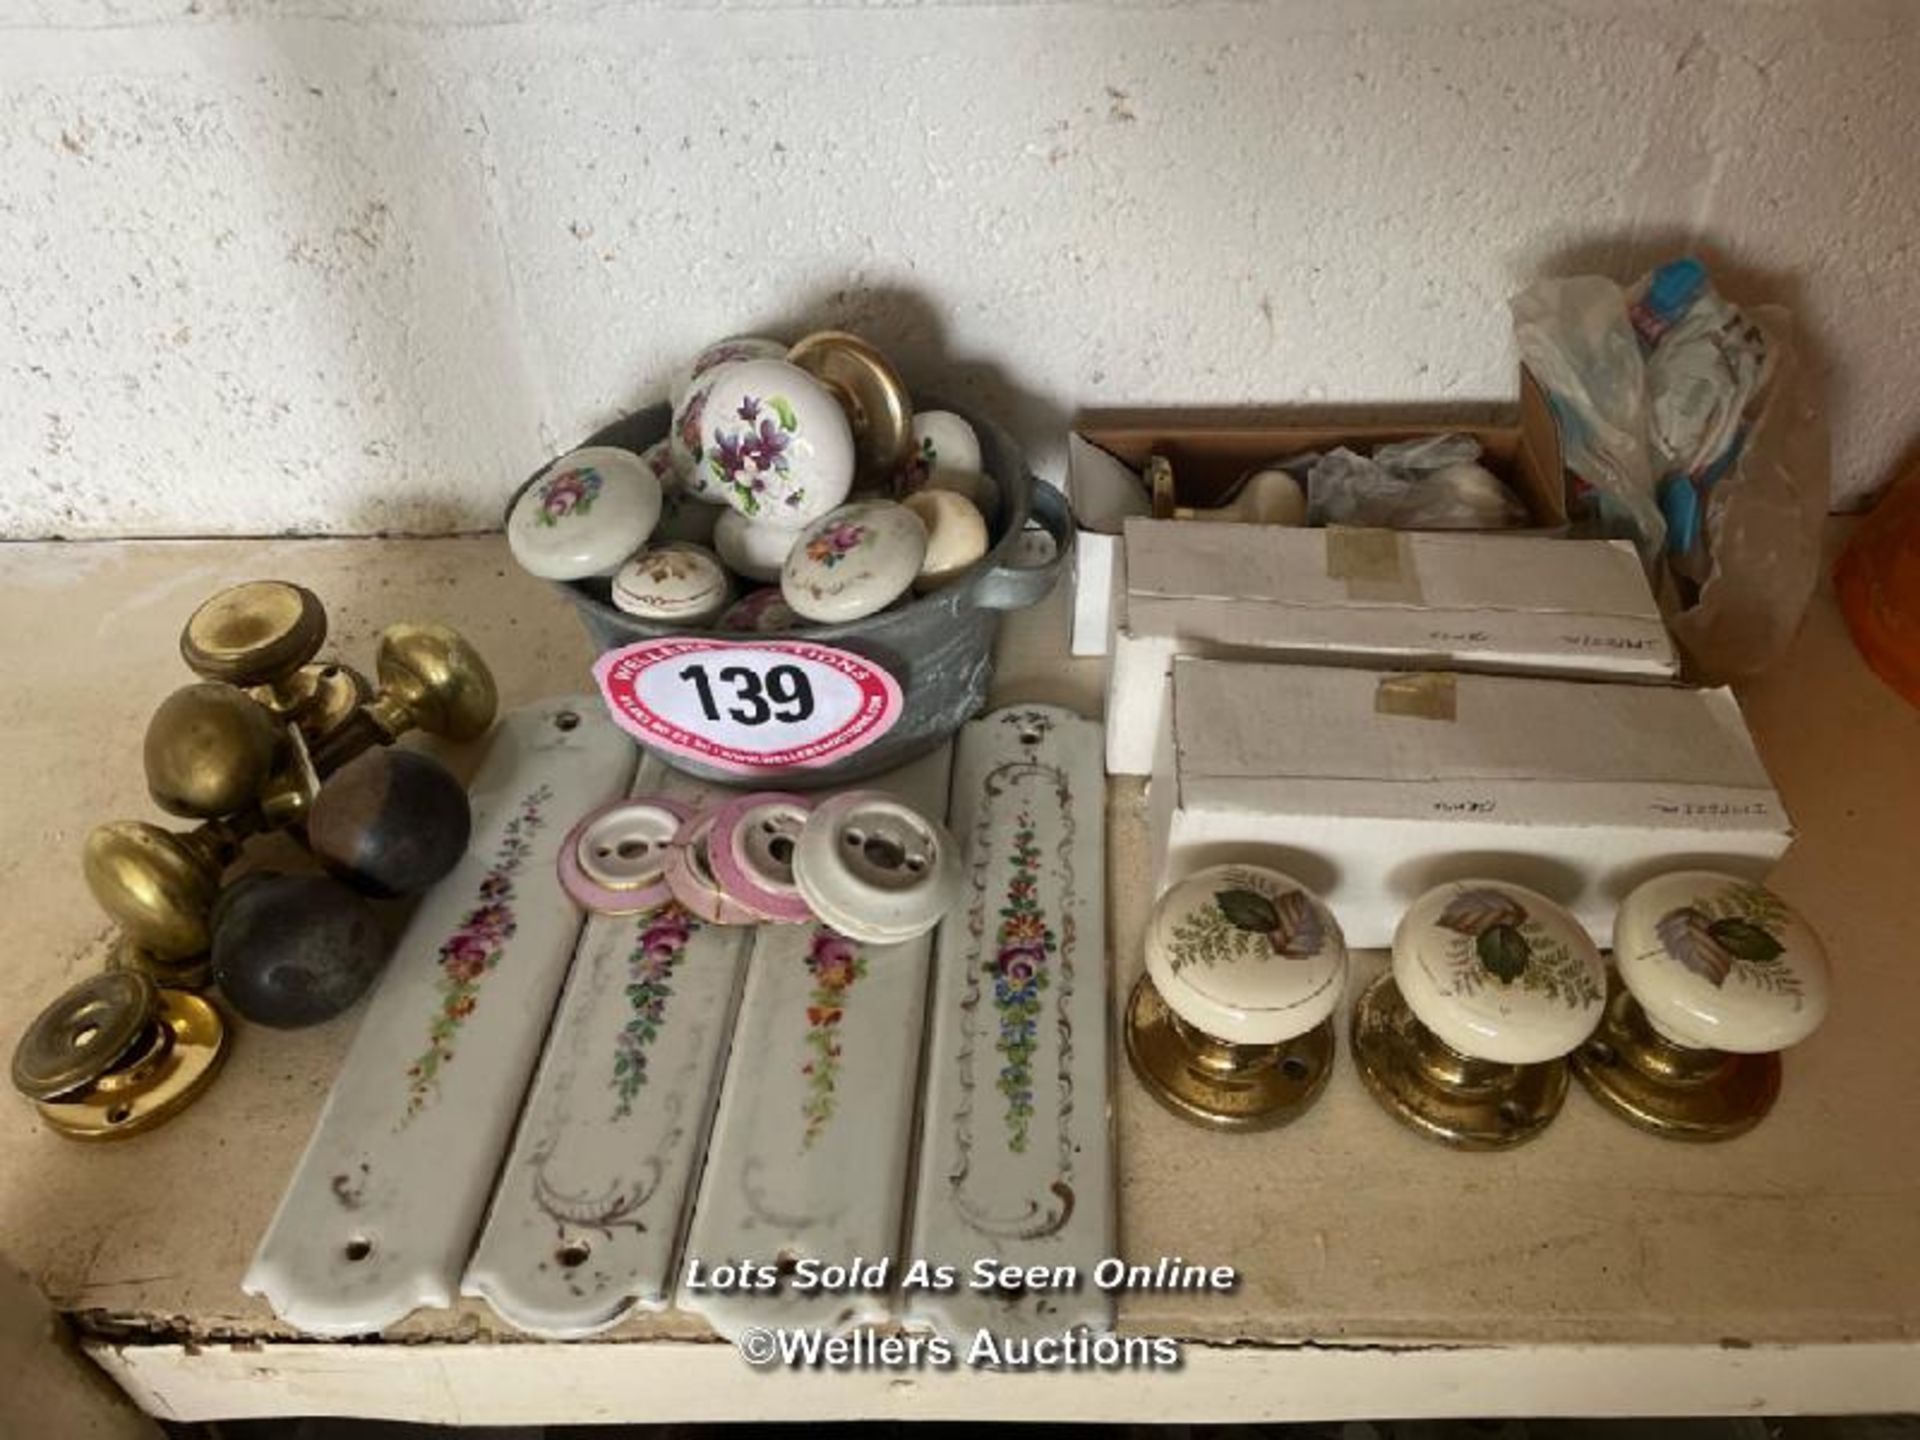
[461,755,753,1338]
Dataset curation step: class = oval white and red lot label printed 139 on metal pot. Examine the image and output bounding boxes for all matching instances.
[593,636,902,776]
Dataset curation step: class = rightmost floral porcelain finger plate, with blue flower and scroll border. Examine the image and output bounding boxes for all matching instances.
[906,705,1116,1336]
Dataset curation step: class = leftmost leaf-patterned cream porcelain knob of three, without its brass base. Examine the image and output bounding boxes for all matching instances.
[1146,864,1346,1044]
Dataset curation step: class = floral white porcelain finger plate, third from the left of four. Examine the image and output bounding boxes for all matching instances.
[676,745,956,1338]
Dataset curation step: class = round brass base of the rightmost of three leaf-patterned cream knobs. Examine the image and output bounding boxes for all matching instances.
[1572,975,1780,1140]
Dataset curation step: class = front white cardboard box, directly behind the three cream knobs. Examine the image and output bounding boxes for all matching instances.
[1148,657,1793,947]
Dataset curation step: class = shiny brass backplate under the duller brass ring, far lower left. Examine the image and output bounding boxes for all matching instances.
[35,990,230,1140]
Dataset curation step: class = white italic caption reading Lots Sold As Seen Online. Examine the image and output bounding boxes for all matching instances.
[685,1256,1240,1294]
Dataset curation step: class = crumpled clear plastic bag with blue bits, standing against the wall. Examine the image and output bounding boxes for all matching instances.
[1513,261,1830,684]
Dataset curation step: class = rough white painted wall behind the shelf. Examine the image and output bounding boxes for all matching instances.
[0,0,1920,536]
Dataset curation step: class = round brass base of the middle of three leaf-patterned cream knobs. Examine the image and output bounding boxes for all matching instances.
[1354,972,1567,1150]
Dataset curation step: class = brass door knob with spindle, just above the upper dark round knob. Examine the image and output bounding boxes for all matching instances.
[313,624,499,778]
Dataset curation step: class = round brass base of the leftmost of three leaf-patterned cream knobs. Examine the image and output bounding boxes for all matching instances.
[1127,975,1334,1131]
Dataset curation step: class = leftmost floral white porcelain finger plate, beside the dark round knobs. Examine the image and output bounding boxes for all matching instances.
[242,695,636,1336]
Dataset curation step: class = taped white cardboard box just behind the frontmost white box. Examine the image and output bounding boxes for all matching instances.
[1106,518,1680,776]
